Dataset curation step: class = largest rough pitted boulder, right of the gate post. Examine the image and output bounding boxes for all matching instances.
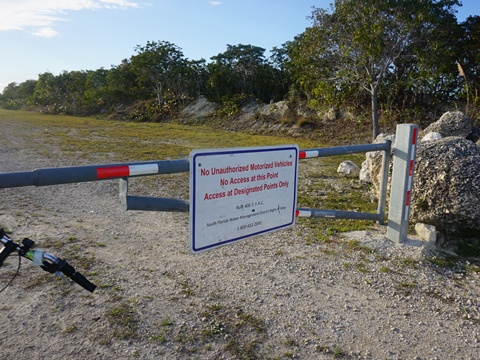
[410,136,480,238]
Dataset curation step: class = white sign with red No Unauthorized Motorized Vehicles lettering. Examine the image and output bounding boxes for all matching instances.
[190,145,298,252]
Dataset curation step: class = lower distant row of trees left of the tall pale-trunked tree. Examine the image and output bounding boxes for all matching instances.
[0,41,284,120]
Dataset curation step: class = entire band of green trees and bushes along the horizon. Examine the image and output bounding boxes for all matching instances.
[0,0,480,136]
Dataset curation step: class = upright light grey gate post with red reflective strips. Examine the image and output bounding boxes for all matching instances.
[387,124,418,243]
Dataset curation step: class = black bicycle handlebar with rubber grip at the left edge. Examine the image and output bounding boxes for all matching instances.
[0,229,97,292]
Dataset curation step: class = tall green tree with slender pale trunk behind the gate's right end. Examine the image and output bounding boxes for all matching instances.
[294,0,459,138]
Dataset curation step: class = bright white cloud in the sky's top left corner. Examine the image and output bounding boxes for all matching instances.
[0,0,139,37]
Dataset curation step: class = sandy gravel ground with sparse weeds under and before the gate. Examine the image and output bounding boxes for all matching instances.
[0,116,480,359]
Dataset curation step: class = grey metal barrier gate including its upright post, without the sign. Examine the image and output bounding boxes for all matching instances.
[0,124,418,242]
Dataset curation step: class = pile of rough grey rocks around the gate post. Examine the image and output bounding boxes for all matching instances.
[360,111,480,249]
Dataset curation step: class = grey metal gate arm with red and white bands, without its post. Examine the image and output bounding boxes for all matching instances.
[0,141,391,224]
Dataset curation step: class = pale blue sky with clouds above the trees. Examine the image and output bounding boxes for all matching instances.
[0,0,480,91]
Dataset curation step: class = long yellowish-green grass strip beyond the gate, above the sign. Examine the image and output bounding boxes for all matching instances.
[0,109,318,161]
